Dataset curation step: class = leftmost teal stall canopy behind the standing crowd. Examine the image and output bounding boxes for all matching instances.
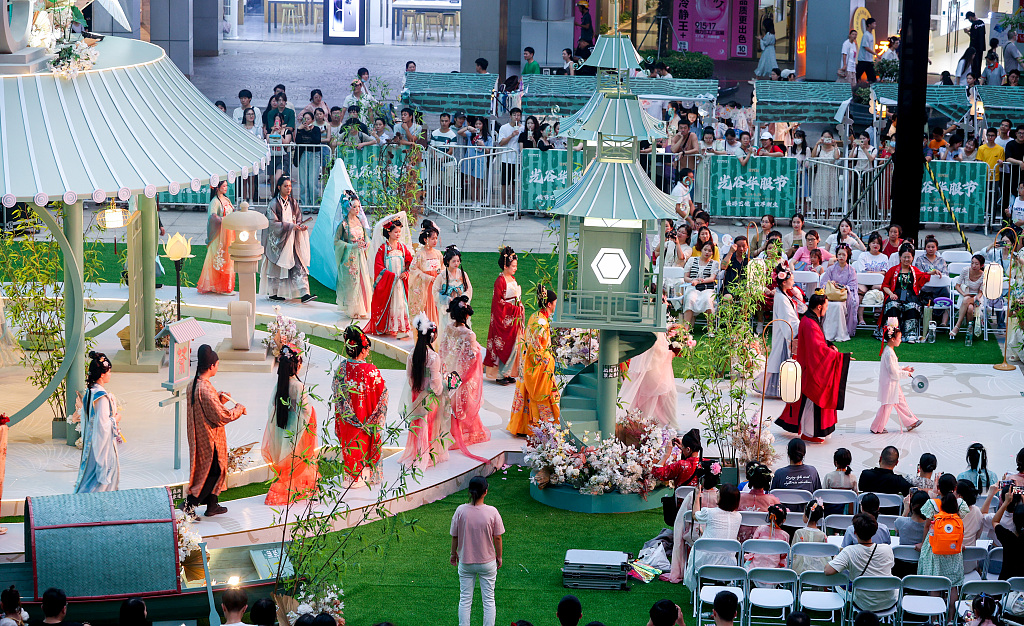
[401,72,498,116]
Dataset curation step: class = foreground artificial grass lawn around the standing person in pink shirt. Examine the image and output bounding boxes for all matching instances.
[327,466,690,626]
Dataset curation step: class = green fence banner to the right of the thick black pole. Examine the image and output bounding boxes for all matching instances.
[921,161,988,224]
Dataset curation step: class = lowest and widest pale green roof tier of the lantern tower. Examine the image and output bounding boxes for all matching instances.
[551,159,676,220]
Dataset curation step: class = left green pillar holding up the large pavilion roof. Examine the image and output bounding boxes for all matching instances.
[63,202,85,446]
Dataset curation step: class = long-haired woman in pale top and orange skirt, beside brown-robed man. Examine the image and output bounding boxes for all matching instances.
[261,344,316,505]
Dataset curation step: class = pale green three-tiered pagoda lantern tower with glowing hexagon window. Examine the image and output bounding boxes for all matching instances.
[552,28,676,439]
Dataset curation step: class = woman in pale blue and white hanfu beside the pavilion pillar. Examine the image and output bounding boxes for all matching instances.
[75,352,124,494]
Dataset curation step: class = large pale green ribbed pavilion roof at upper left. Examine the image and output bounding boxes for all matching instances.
[0,37,269,206]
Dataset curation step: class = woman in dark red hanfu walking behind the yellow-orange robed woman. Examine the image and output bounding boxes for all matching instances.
[483,246,524,385]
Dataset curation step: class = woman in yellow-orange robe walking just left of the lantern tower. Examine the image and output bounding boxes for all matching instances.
[509,285,558,436]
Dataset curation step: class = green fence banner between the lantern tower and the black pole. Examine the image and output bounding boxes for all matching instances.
[708,157,798,217]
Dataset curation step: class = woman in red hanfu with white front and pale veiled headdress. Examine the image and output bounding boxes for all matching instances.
[366,218,413,339]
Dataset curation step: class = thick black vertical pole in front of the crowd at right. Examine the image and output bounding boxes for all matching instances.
[890,0,931,246]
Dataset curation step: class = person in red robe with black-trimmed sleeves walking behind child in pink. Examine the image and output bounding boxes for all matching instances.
[775,289,850,444]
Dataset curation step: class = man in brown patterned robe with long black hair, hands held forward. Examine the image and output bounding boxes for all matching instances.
[181,344,246,517]
